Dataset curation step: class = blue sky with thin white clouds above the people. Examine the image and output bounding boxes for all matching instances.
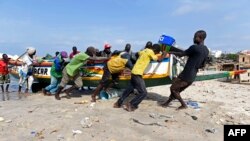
[0,0,250,56]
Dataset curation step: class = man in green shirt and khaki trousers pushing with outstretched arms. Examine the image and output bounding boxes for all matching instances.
[55,47,107,100]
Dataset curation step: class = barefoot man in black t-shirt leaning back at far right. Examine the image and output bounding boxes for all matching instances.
[162,30,209,109]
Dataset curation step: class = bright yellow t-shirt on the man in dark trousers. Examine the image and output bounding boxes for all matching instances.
[132,48,158,75]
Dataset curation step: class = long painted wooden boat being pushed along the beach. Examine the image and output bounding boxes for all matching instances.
[10,55,244,92]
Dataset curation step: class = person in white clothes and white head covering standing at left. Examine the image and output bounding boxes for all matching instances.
[18,47,36,94]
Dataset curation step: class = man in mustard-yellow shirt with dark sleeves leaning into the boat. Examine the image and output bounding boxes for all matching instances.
[91,51,133,102]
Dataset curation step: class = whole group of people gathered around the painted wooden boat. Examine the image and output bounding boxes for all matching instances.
[0,30,209,112]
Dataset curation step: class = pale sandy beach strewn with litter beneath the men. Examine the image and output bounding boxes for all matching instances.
[0,80,250,141]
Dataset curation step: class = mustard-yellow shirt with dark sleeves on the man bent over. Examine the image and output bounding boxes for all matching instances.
[108,55,128,74]
